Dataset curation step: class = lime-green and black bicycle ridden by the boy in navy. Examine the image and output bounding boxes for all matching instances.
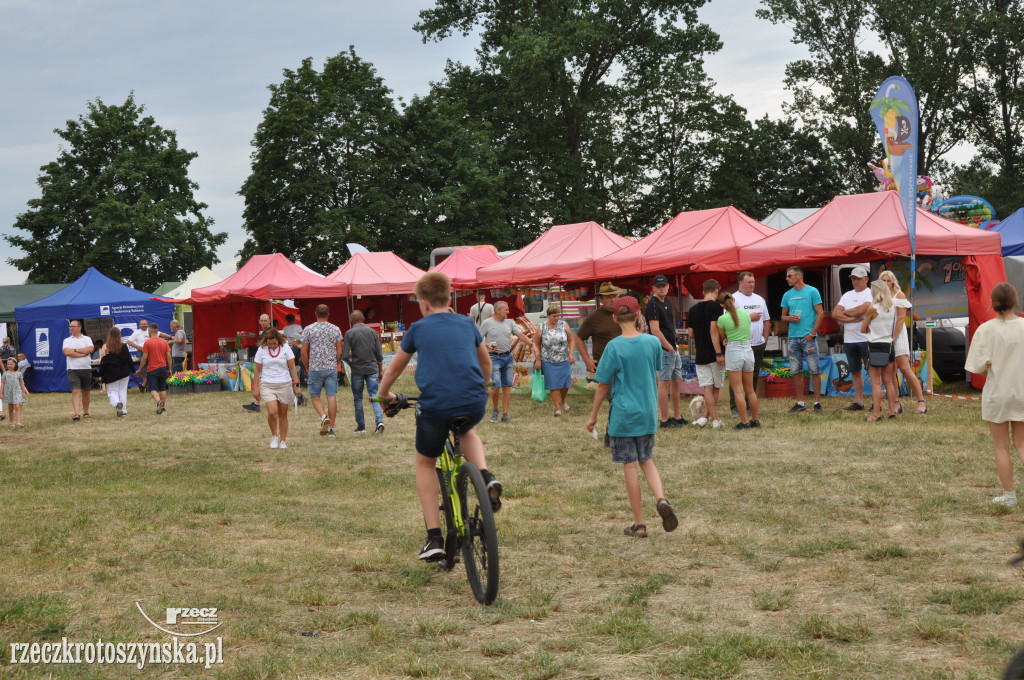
[373,394,499,604]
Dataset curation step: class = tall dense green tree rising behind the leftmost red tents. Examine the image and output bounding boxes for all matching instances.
[239,47,400,271]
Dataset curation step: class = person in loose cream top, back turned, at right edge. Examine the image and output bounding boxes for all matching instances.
[965,283,1024,508]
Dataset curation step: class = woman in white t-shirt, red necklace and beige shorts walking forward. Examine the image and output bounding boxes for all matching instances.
[253,329,300,449]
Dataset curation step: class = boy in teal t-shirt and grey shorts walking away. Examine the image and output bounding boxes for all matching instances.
[587,295,679,539]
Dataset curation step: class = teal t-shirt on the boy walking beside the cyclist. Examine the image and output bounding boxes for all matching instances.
[594,335,662,437]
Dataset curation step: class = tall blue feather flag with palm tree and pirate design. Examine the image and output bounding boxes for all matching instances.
[870,76,919,289]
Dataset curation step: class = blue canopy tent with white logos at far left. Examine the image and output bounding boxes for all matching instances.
[14,267,174,392]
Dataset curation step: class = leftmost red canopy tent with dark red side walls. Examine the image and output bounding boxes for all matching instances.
[172,253,348,363]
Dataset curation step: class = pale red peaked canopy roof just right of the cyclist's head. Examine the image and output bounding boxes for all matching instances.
[476,222,630,288]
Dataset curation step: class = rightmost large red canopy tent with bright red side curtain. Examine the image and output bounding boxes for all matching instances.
[739,192,1006,386]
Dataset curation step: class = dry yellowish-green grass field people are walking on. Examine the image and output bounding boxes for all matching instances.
[0,381,1024,679]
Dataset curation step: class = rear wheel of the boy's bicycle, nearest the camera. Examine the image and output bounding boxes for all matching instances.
[459,461,498,604]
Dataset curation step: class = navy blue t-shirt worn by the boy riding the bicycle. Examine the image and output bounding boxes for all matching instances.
[401,312,487,415]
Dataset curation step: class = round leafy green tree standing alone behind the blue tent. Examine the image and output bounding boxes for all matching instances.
[4,94,227,291]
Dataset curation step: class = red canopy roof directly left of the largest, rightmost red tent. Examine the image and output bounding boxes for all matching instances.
[594,206,777,279]
